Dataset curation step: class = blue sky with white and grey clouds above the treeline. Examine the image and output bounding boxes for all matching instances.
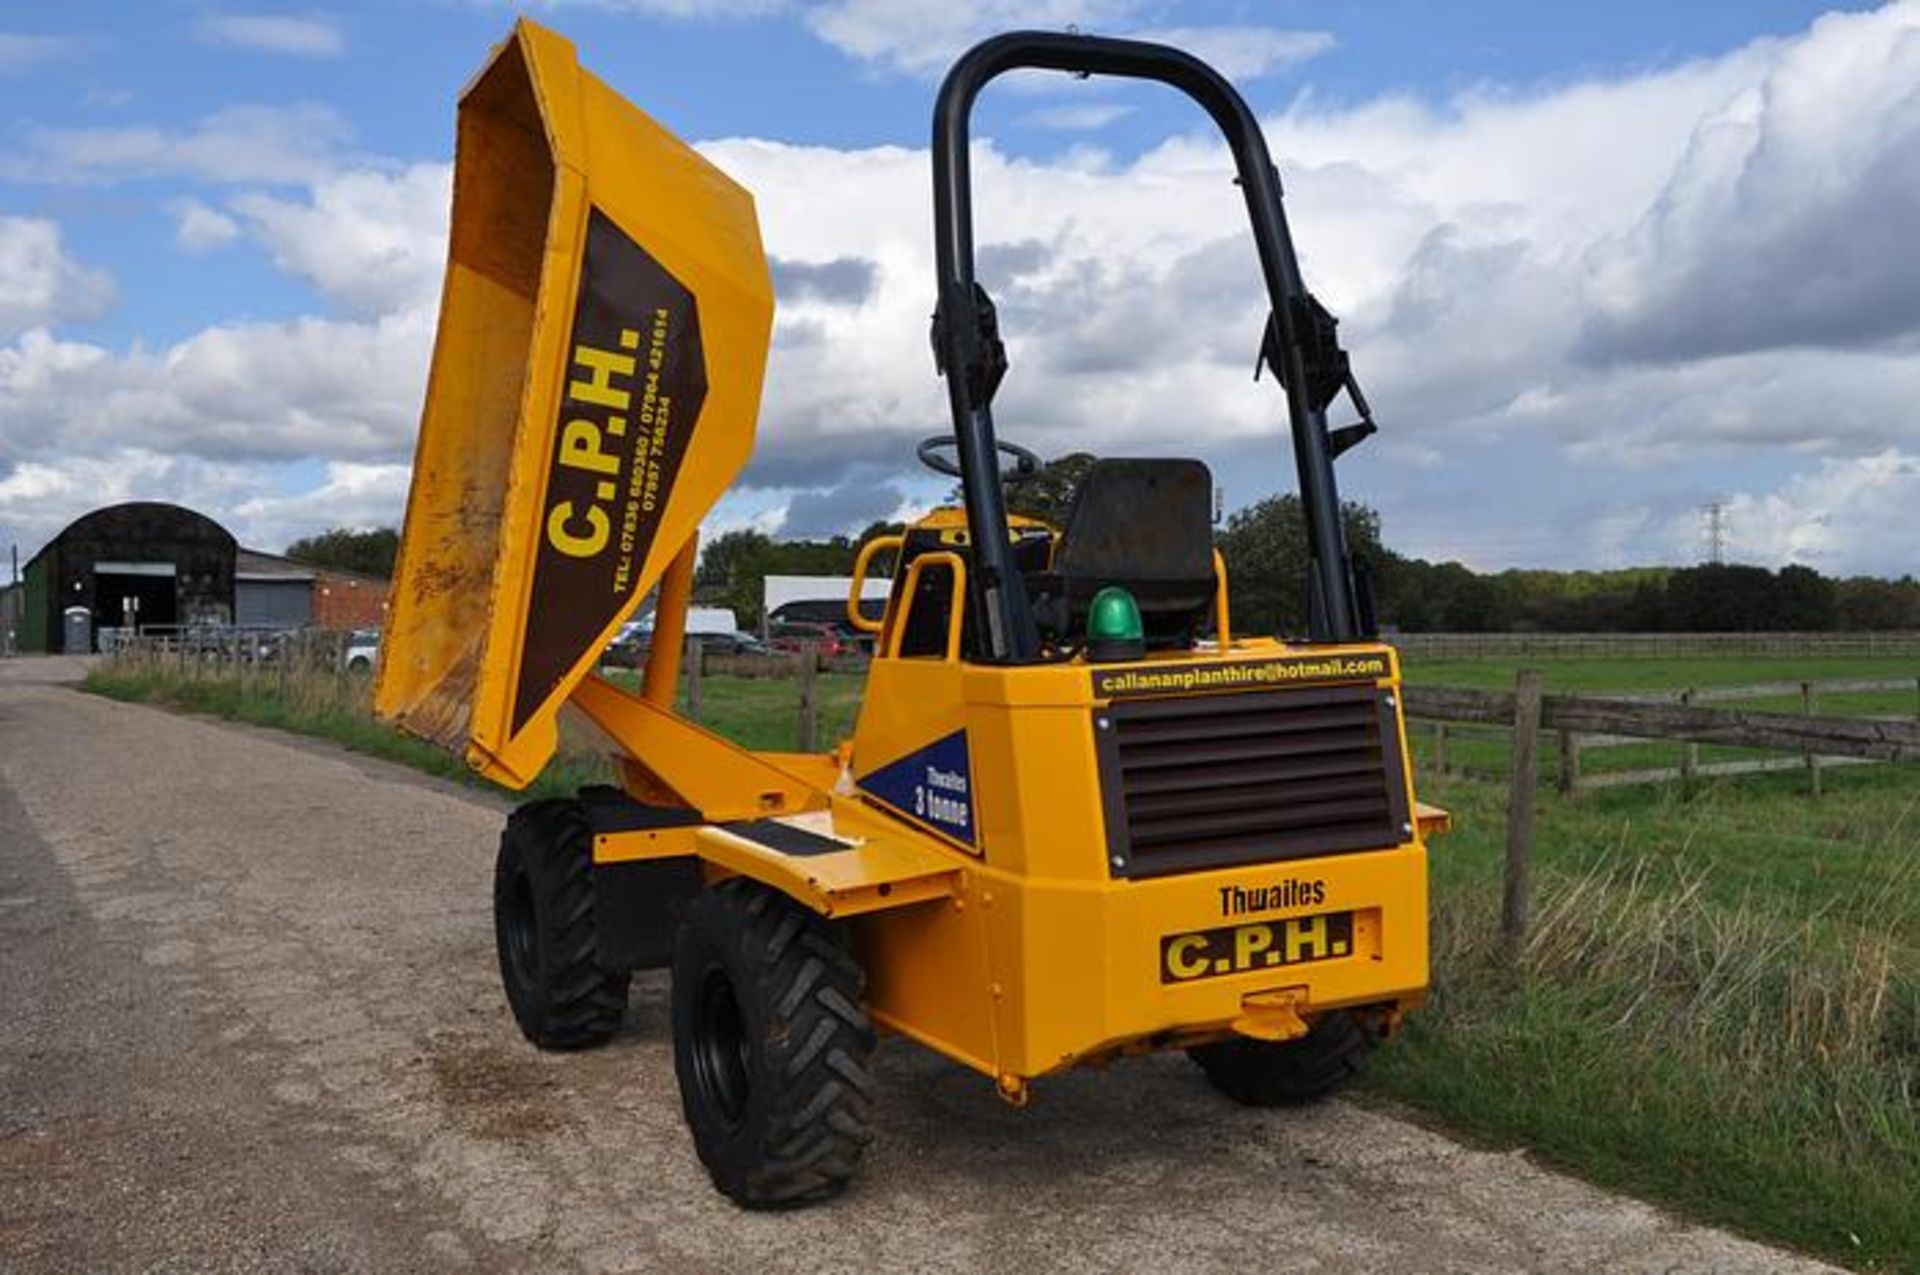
[0,0,1920,574]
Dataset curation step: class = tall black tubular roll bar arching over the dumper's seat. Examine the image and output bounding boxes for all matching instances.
[933,31,1361,664]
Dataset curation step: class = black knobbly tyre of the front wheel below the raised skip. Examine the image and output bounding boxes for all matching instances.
[493,799,632,1050]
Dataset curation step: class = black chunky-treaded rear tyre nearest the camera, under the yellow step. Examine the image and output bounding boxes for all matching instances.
[674,878,874,1210]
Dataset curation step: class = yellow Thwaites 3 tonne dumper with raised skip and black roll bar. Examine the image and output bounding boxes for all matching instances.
[376,21,1444,1208]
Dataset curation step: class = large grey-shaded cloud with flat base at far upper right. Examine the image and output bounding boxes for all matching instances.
[1582,4,1920,363]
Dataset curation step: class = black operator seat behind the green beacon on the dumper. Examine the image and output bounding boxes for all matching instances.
[1025,459,1215,649]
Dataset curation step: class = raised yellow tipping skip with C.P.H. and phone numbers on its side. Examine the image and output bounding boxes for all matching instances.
[374,21,774,787]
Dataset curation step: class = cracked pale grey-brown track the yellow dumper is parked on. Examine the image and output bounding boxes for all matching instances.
[0,659,1826,1273]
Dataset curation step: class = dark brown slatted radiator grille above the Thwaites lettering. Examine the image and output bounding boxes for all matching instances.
[1094,686,1411,878]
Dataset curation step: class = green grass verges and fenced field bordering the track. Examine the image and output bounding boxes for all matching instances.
[90,659,1920,1271]
